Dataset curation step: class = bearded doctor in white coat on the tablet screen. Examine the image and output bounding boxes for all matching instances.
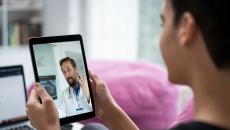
[59,57,92,117]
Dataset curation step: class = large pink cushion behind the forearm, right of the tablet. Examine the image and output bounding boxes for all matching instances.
[81,61,179,130]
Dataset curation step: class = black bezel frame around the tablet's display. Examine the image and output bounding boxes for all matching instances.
[29,34,95,125]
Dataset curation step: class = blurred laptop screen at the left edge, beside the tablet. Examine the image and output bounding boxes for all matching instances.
[0,66,27,125]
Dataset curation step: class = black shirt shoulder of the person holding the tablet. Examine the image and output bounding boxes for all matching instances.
[170,121,229,130]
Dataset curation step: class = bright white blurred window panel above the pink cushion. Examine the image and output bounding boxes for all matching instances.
[79,0,139,60]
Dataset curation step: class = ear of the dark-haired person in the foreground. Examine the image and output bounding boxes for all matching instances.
[177,12,196,46]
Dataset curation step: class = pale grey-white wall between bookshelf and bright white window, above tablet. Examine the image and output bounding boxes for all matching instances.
[43,0,83,36]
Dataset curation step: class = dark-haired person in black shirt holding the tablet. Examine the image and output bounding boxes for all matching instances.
[27,0,230,130]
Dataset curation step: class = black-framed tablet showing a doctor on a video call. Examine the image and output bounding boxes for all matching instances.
[29,35,95,125]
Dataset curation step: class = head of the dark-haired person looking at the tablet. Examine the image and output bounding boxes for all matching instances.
[161,0,230,84]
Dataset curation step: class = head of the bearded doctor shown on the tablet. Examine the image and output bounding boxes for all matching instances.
[59,57,78,87]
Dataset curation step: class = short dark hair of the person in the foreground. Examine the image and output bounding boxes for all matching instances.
[171,0,230,69]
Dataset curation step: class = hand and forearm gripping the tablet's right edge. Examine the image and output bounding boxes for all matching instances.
[89,72,138,130]
